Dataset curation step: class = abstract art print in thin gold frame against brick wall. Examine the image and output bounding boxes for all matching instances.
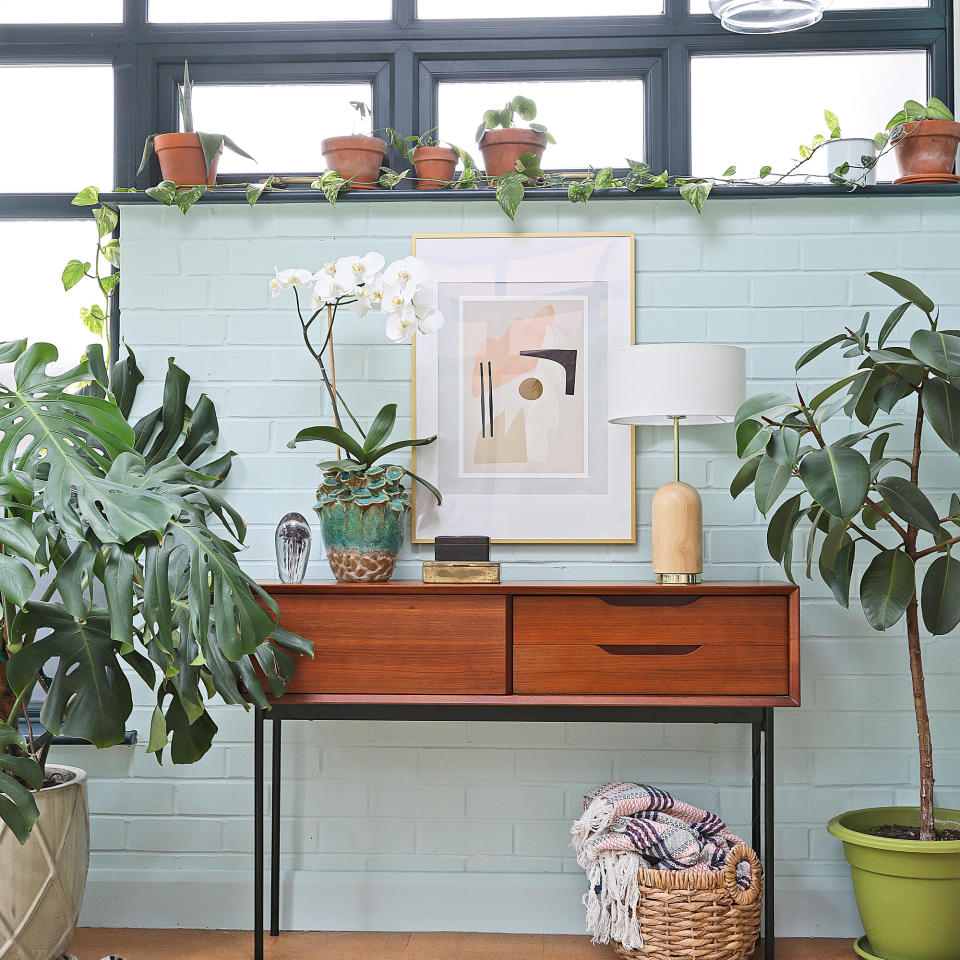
[413,233,636,543]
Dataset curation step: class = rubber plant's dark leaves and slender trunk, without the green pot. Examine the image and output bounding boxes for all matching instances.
[731,273,960,840]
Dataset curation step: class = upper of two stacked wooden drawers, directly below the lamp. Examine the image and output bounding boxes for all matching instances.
[513,593,790,647]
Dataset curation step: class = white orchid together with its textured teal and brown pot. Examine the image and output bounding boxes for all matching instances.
[270,253,444,582]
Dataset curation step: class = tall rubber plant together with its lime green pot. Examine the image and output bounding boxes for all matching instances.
[731,273,960,960]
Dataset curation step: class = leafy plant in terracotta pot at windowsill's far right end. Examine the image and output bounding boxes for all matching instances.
[887,97,960,183]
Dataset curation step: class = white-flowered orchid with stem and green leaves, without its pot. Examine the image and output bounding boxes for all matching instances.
[269,253,444,503]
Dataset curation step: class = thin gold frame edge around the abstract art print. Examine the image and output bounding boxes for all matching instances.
[411,231,637,544]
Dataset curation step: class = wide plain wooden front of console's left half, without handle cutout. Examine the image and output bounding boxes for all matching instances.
[276,594,507,694]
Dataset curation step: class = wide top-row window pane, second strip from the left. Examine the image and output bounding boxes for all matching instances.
[149,0,393,23]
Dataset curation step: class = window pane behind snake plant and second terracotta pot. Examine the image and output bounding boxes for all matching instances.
[184,83,372,173]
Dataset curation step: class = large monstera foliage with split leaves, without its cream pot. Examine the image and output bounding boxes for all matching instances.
[0,340,312,843]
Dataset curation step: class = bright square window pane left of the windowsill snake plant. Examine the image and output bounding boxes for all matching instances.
[0,64,114,193]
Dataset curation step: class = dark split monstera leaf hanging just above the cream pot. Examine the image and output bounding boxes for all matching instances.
[7,600,133,747]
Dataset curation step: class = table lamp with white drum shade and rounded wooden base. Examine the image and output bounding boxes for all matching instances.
[607,343,746,584]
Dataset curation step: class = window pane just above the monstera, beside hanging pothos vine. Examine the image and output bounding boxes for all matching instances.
[0,217,109,384]
